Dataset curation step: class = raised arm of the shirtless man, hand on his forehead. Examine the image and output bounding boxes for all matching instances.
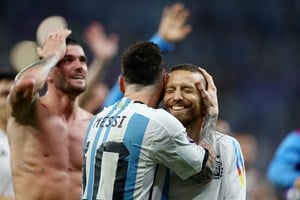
[8,30,71,121]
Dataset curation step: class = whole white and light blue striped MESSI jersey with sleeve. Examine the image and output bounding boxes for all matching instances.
[82,97,204,200]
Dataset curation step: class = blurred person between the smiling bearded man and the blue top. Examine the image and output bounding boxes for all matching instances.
[234,133,276,200]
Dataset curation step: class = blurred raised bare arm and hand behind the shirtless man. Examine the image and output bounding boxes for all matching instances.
[79,22,119,114]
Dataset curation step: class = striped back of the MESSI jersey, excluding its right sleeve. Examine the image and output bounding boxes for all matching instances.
[83,98,176,199]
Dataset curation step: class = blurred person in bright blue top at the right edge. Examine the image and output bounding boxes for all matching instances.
[267,129,300,198]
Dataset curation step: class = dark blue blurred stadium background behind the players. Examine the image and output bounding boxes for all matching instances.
[0,0,300,170]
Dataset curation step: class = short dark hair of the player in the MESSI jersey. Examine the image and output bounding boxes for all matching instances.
[121,41,165,85]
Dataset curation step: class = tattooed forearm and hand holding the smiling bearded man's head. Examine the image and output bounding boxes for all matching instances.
[192,68,219,184]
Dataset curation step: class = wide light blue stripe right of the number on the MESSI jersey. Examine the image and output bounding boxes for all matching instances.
[123,114,149,200]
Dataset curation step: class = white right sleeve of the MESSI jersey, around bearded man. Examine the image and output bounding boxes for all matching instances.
[151,111,205,180]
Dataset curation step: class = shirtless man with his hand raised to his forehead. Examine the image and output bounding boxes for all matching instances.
[8,30,92,200]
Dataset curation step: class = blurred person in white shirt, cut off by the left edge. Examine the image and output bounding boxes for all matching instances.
[0,68,16,200]
